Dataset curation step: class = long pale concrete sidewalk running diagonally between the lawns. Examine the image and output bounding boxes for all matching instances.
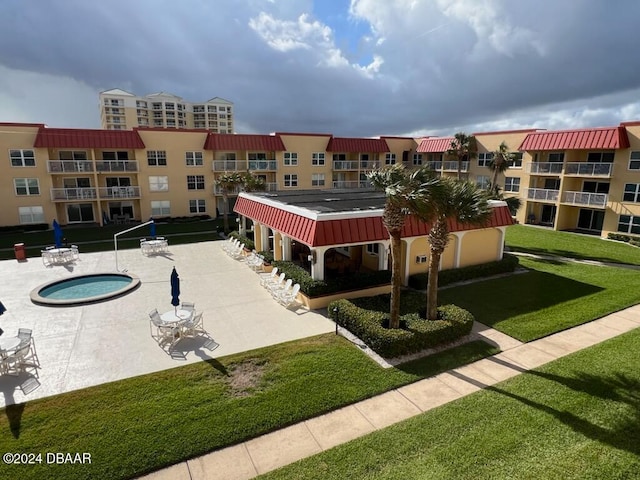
[143,305,640,480]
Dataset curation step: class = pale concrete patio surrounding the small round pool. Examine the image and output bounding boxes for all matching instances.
[0,241,335,406]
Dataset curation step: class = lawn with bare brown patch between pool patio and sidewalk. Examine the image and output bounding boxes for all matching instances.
[0,335,497,480]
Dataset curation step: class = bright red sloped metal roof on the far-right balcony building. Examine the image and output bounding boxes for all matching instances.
[518,127,629,151]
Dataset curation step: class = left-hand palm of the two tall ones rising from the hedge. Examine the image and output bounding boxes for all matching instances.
[367,164,437,328]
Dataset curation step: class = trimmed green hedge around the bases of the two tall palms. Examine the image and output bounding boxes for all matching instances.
[327,299,474,358]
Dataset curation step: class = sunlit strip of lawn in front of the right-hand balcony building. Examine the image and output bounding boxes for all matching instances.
[506,225,640,265]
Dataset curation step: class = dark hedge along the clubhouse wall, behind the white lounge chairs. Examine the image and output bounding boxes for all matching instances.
[273,260,391,297]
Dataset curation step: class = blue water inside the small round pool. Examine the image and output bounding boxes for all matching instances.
[38,275,133,300]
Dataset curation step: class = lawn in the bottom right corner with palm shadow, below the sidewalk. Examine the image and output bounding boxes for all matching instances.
[260,329,640,480]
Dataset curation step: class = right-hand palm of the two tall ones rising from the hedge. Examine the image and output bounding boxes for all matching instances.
[411,177,491,320]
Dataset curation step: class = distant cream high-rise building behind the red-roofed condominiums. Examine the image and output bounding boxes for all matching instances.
[100,88,234,133]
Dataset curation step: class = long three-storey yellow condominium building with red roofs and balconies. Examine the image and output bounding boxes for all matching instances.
[0,121,640,240]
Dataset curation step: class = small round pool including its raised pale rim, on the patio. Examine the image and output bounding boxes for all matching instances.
[30,273,140,306]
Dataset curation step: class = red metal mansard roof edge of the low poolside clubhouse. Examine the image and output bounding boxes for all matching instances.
[234,196,513,247]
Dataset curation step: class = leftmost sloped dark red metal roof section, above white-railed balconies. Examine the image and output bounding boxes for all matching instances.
[33,127,145,150]
